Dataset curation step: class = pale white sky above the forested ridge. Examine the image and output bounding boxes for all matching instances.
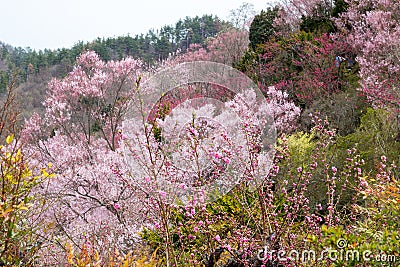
[0,0,268,50]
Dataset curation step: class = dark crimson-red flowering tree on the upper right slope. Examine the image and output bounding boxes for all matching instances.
[246,33,351,107]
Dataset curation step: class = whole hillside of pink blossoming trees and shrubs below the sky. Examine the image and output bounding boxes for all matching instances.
[0,0,400,267]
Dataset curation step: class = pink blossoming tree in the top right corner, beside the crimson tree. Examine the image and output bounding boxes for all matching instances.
[337,0,400,107]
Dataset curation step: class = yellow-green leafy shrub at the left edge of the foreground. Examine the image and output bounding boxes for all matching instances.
[0,135,53,266]
